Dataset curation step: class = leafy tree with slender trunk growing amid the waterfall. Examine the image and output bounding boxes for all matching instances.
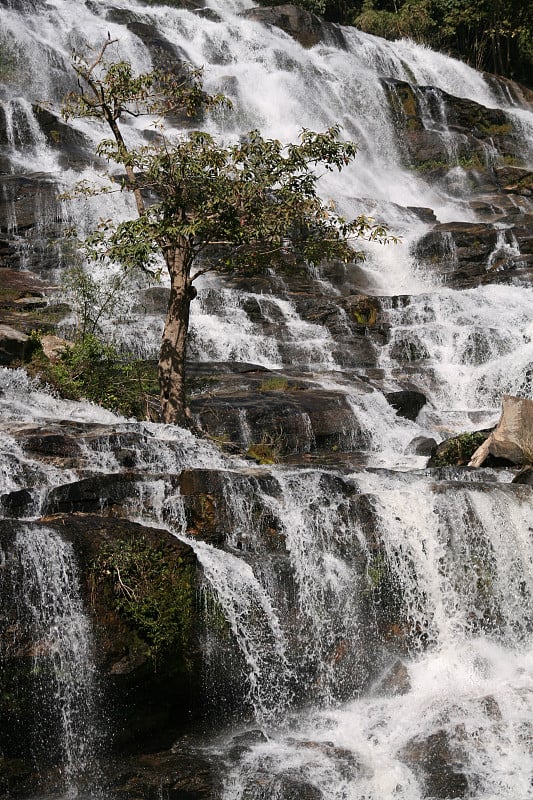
[64,39,388,423]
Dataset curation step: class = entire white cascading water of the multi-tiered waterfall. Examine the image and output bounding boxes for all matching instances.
[0,0,533,800]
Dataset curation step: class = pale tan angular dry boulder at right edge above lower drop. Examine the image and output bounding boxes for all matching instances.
[469,395,533,467]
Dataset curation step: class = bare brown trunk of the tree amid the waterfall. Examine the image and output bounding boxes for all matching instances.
[159,241,195,424]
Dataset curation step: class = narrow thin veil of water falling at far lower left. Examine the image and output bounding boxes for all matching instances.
[4,524,99,797]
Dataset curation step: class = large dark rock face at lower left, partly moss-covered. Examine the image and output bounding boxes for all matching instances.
[0,513,203,780]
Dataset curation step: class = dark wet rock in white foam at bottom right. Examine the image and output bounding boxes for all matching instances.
[400,730,469,800]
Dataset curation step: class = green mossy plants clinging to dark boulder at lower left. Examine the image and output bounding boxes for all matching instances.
[93,536,196,671]
